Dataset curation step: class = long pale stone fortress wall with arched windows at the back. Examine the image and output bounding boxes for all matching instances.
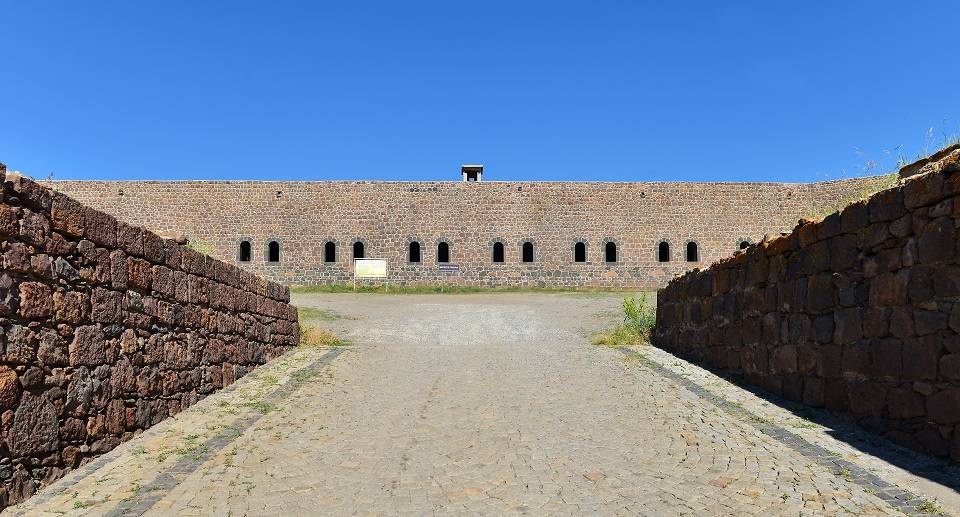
[52,178,876,289]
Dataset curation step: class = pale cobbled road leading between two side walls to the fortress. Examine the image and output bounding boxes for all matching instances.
[10,294,952,515]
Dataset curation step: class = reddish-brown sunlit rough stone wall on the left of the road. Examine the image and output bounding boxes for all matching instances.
[0,165,298,509]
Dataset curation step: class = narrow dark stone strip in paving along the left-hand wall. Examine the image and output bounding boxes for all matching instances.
[91,348,344,517]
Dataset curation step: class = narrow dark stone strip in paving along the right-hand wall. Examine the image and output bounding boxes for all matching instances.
[617,347,940,516]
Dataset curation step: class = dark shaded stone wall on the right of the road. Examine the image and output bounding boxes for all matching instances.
[653,151,960,460]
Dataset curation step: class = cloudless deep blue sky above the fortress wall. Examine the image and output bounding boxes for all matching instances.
[0,0,960,181]
